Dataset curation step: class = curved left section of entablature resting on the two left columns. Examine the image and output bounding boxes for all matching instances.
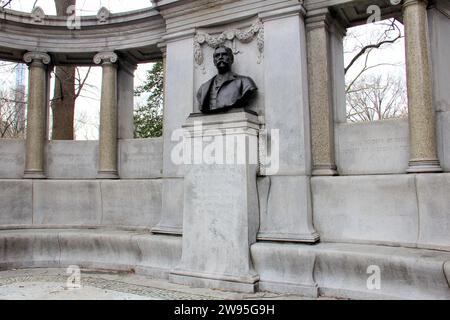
[0,9,166,65]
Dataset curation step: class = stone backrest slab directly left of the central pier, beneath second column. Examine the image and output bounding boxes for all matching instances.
[101,180,161,228]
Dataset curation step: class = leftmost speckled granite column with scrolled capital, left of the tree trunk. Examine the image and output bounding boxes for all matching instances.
[23,52,51,179]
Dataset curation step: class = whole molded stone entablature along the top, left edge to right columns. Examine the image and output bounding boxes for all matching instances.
[0,0,408,64]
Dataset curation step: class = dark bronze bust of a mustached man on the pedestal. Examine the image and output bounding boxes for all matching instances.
[197,46,257,113]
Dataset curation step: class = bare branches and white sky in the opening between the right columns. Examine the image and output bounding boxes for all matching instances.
[345,19,407,122]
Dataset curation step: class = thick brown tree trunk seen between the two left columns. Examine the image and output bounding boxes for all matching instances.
[51,0,76,140]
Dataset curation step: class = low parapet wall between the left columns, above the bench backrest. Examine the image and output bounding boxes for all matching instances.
[0,138,162,180]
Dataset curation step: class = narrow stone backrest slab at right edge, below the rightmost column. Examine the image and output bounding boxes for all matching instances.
[416,174,450,251]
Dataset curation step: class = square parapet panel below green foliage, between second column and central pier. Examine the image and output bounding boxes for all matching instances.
[119,138,163,179]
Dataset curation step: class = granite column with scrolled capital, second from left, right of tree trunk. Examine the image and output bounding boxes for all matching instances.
[94,52,118,179]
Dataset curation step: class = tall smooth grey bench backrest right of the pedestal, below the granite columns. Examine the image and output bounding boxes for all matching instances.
[311,174,450,251]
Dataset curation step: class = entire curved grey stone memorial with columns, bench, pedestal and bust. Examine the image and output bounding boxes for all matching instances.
[0,0,450,299]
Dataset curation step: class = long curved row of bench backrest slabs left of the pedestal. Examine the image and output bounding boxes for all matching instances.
[0,179,161,229]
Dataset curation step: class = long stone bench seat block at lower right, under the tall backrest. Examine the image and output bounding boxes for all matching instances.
[314,244,450,299]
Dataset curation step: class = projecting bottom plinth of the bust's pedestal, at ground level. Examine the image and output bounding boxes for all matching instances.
[169,270,259,293]
